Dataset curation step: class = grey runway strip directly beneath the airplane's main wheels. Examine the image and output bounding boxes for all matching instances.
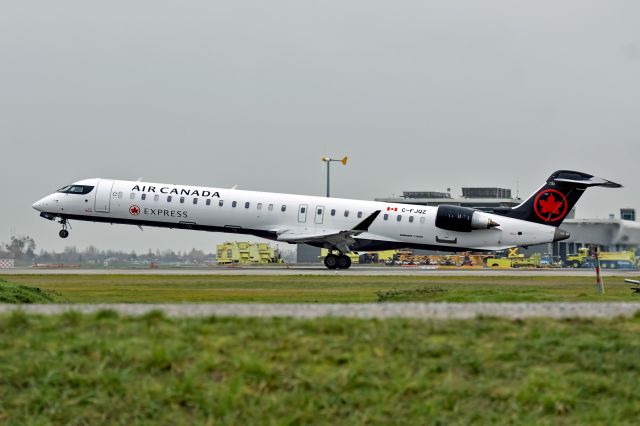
[0,266,640,277]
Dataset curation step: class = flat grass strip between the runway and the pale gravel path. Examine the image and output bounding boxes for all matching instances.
[2,275,640,303]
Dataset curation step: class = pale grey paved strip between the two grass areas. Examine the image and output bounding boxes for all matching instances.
[0,302,640,319]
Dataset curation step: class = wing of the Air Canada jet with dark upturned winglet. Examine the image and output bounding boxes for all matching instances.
[278,210,380,253]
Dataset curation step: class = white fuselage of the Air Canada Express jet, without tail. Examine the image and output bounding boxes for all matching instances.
[33,179,557,255]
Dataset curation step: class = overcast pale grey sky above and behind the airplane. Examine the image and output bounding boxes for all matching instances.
[0,0,640,251]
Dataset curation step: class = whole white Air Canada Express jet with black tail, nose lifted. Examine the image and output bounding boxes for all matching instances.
[33,170,621,269]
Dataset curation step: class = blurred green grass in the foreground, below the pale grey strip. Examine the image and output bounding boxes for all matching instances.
[0,311,640,425]
